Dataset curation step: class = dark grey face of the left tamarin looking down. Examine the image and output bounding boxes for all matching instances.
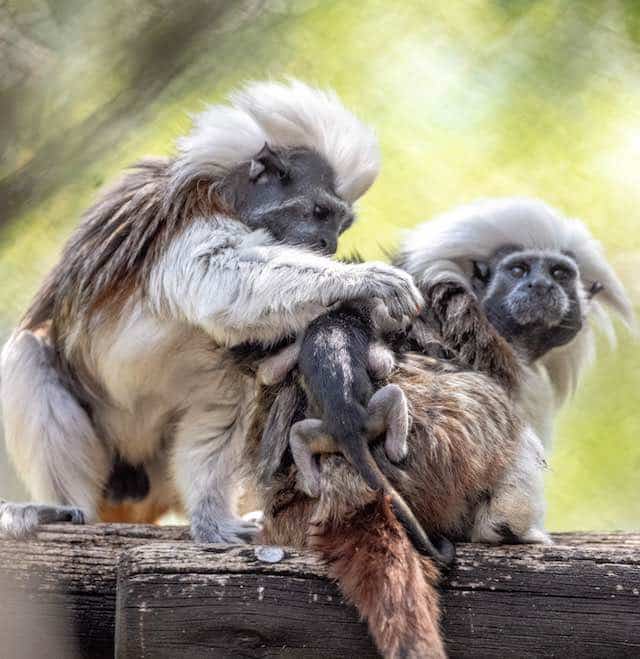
[225,145,354,254]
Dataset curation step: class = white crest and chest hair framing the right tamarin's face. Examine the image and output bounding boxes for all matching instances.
[401,197,634,448]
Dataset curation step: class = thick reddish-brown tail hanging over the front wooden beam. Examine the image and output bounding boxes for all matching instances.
[309,458,446,659]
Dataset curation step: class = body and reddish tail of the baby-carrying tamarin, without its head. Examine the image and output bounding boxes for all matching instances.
[247,336,532,657]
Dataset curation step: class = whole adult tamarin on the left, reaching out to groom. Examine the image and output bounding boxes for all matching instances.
[0,82,421,542]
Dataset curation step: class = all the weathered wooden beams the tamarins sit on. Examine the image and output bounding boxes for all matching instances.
[0,525,640,657]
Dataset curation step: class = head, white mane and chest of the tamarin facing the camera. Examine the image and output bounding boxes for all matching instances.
[395,197,634,447]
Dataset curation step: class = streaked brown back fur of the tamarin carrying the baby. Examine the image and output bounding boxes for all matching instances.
[254,354,521,546]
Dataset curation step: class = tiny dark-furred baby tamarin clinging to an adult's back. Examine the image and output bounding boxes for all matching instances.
[259,301,453,563]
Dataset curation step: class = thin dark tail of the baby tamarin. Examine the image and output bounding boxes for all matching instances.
[345,439,455,566]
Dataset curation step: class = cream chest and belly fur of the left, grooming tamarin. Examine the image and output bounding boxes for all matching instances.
[84,304,250,462]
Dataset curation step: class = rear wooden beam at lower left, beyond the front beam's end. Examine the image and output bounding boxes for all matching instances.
[0,524,189,659]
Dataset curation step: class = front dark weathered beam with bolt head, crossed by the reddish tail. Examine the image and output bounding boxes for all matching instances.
[116,535,640,657]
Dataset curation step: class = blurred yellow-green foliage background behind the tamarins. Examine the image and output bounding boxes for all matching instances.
[0,0,640,530]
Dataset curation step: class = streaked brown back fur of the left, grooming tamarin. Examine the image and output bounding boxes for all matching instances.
[22,158,223,344]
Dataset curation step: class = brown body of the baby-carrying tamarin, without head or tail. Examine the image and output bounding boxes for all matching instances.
[248,338,544,545]
